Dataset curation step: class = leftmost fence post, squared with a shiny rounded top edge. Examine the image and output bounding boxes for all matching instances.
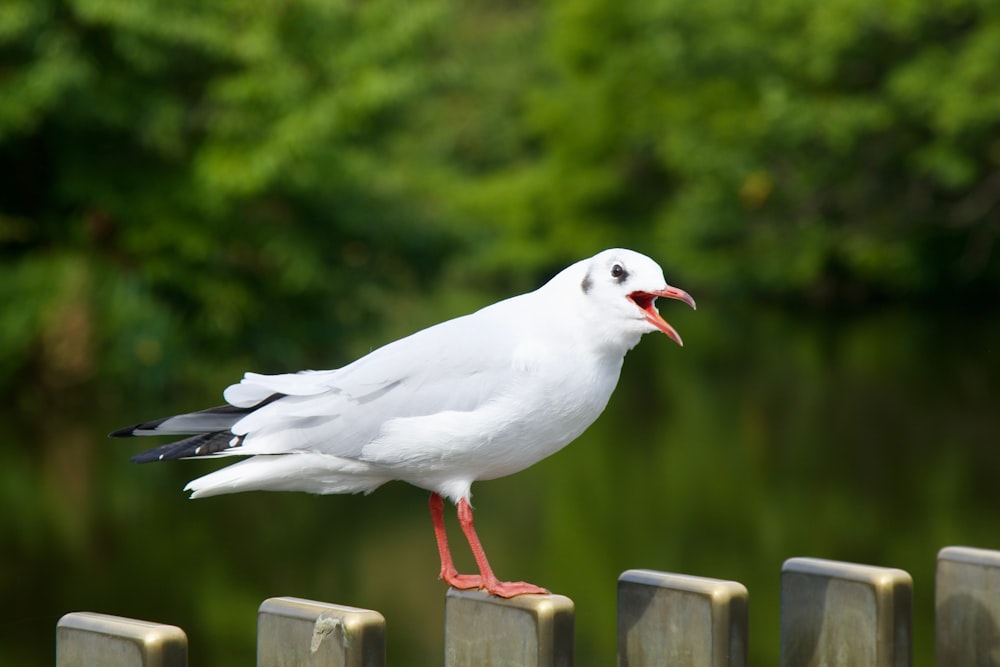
[56,611,187,667]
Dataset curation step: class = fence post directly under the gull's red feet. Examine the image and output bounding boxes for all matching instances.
[444,588,574,667]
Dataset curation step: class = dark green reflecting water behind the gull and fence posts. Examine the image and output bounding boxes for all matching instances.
[0,307,1000,666]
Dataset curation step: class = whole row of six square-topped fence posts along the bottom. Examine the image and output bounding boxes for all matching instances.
[56,547,1000,667]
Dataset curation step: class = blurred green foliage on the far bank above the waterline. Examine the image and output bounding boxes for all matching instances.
[0,0,1000,396]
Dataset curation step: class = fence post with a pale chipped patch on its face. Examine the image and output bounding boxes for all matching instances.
[257,597,385,667]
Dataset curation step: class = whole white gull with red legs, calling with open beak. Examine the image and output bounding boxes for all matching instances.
[110,248,695,598]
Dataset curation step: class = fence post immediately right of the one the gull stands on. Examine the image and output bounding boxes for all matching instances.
[618,570,748,667]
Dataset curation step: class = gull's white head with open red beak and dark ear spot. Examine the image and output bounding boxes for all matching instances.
[578,248,696,345]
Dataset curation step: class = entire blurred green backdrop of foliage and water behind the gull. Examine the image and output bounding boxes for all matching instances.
[0,0,1000,666]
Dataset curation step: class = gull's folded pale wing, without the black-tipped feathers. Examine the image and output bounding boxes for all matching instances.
[225,300,528,458]
